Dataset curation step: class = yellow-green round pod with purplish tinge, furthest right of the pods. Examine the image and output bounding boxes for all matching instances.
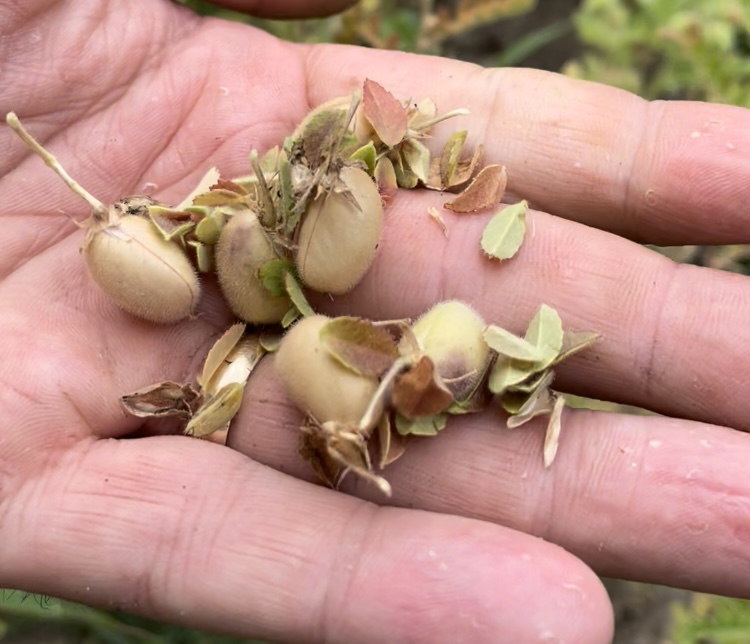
[412,300,490,403]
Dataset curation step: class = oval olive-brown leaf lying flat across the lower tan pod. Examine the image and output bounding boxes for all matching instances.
[320,317,406,377]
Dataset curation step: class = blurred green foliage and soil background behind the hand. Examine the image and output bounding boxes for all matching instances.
[5,0,750,644]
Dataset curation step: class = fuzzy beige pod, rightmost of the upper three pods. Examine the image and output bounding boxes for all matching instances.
[296,167,383,295]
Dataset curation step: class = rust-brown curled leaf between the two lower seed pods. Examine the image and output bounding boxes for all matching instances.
[391,356,453,418]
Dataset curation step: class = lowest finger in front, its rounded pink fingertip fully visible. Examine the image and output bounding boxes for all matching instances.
[0,437,612,643]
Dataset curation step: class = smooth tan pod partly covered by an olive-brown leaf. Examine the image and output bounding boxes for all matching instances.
[274,315,378,425]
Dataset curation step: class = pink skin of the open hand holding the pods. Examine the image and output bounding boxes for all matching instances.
[0,0,750,642]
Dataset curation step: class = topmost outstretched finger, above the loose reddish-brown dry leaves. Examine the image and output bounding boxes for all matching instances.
[305,42,750,245]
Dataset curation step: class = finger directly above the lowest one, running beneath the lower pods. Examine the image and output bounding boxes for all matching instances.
[229,363,750,597]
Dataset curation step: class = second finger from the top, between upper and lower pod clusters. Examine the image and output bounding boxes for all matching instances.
[298,193,750,430]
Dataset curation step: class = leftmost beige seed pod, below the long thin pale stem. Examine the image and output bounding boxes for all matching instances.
[81,215,200,324]
